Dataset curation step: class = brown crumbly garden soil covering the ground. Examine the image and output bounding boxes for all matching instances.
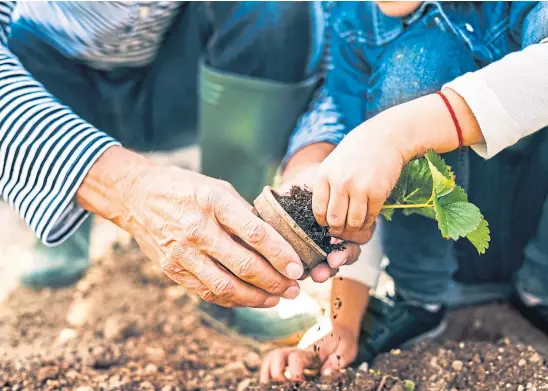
[0,243,548,391]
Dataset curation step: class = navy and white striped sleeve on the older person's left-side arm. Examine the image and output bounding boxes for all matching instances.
[0,2,119,245]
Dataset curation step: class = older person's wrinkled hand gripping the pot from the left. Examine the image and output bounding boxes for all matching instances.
[77,147,304,307]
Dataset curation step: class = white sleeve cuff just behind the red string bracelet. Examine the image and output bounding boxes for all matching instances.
[443,73,521,159]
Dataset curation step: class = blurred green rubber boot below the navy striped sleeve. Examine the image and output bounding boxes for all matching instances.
[21,218,92,289]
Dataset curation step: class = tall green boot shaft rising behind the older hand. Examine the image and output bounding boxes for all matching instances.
[199,63,317,201]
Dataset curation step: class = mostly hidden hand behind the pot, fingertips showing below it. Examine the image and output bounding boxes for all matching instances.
[278,164,366,282]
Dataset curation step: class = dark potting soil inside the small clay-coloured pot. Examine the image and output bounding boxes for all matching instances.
[276,186,345,254]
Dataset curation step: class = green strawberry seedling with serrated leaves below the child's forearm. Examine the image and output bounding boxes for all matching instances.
[381,151,491,254]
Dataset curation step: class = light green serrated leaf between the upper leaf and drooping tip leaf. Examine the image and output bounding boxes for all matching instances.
[434,201,481,240]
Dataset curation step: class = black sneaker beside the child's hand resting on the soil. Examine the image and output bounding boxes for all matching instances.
[356,296,447,364]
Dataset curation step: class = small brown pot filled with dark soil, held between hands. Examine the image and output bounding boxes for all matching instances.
[253,186,344,269]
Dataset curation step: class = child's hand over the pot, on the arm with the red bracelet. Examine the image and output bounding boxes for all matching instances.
[312,114,407,244]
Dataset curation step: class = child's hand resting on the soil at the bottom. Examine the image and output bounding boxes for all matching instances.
[260,326,358,383]
